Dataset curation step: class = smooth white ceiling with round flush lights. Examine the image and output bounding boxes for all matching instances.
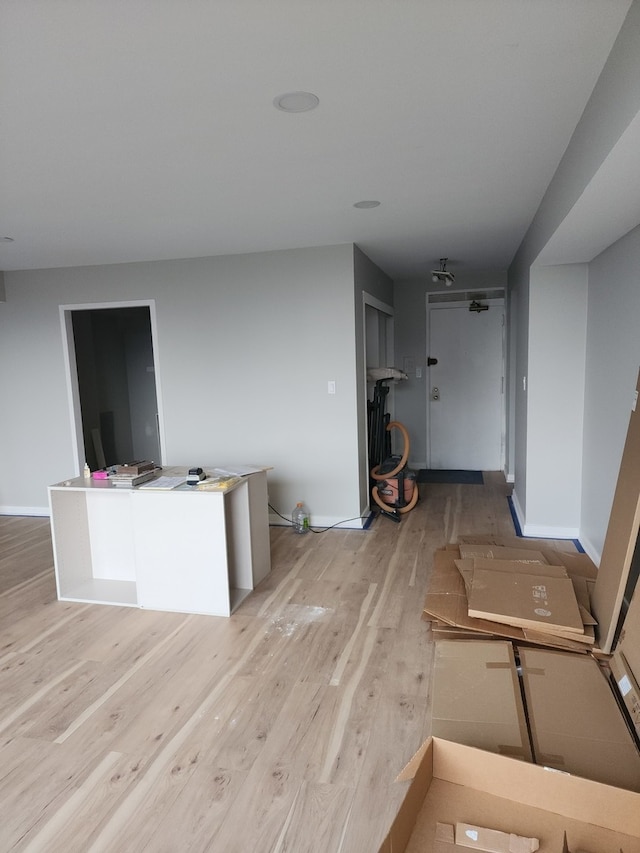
[0,0,630,279]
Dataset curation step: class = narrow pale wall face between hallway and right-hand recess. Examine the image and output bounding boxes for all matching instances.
[523,264,587,539]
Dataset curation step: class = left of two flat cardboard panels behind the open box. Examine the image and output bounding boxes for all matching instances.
[432,640,531,761]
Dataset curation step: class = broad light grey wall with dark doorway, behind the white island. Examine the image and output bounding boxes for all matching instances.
[0,244,360,526]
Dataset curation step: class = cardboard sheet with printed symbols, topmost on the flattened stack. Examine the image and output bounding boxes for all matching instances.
[468,569,584,636]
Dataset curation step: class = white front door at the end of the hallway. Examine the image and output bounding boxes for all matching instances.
[427,299,504,471]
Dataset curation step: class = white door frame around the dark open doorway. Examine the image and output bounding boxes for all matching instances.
[59,299,166,476]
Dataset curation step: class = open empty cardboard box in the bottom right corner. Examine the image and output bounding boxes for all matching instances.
[378,738,640,853]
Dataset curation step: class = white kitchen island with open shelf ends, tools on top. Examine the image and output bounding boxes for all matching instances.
[49,468,271,616]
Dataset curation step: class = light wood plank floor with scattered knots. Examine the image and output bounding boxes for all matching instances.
[0,474,514,853]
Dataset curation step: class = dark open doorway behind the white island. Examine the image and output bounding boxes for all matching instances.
[61,303,162,470]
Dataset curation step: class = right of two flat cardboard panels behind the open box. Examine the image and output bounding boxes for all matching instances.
[518,648,640,791]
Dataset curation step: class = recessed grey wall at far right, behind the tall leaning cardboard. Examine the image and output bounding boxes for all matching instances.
[580,226,640,563]
